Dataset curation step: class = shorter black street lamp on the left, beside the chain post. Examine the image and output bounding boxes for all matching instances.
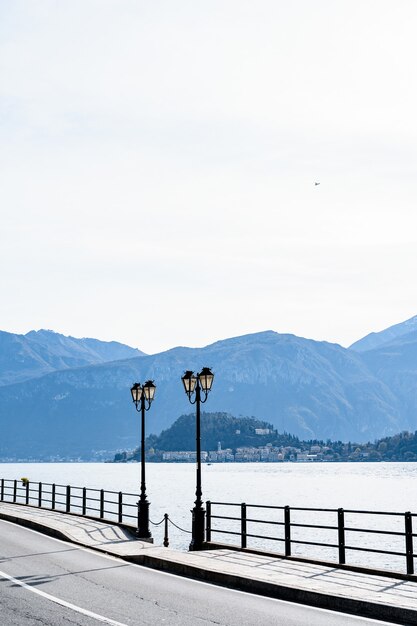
[130,380,156,540]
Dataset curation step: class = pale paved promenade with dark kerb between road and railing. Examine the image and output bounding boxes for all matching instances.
[0,502,417,625]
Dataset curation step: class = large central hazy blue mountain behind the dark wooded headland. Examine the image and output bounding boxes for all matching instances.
[0,331,408,458]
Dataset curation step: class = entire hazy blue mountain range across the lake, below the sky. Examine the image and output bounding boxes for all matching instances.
[0,316,417,460]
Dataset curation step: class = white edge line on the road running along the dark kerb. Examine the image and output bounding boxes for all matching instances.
[0,519,395,626]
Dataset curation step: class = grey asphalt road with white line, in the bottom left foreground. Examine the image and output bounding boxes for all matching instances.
[0,521,396,626]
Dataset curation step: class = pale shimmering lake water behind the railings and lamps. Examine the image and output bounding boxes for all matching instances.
[0,463,417,571]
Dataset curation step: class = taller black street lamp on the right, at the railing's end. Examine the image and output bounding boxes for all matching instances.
[181,367,214,550]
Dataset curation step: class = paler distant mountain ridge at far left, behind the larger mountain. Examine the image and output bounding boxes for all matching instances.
[0,330,143,385]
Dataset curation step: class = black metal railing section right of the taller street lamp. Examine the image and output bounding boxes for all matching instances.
[206,502,417,576]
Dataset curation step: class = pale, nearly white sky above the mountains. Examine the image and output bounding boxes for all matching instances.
[0,0,417,353]
